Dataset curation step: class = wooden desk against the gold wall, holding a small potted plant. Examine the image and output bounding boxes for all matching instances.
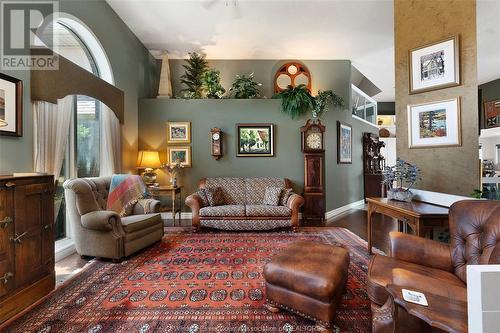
[366,198,448,254]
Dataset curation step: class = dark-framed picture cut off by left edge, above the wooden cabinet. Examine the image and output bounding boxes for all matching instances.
[0,73,23,136]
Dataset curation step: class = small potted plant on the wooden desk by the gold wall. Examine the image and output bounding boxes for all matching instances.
[382,158,422,202]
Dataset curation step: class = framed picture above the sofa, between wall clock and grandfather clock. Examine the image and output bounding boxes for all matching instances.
[236,124,274,157]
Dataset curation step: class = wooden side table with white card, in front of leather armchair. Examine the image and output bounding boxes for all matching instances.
[387,284,468,333]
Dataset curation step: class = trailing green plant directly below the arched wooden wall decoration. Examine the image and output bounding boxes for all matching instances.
[273,84,314,119]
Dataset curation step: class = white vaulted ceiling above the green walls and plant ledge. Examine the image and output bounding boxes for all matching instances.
[106,0,500,101]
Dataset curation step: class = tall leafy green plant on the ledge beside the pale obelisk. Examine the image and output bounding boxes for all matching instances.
[181,52,208,98]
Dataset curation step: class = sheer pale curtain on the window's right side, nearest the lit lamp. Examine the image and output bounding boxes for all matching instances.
[99,103,122,177]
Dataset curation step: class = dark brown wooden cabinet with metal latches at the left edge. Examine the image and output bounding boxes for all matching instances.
[0,176,55,323]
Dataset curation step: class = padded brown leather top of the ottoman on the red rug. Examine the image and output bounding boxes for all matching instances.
[264,241,349,302]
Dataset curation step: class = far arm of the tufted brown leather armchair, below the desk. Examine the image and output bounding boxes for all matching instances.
[389,232,453,272]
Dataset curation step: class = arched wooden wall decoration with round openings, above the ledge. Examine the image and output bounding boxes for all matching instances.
[274,61,311,93]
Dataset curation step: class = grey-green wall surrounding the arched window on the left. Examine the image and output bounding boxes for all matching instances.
[0,0,159,174]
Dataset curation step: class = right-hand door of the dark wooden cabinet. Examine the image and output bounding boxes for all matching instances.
[12,183,49,287]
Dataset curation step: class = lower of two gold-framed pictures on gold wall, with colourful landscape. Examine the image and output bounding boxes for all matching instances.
[408,97,462,148]
